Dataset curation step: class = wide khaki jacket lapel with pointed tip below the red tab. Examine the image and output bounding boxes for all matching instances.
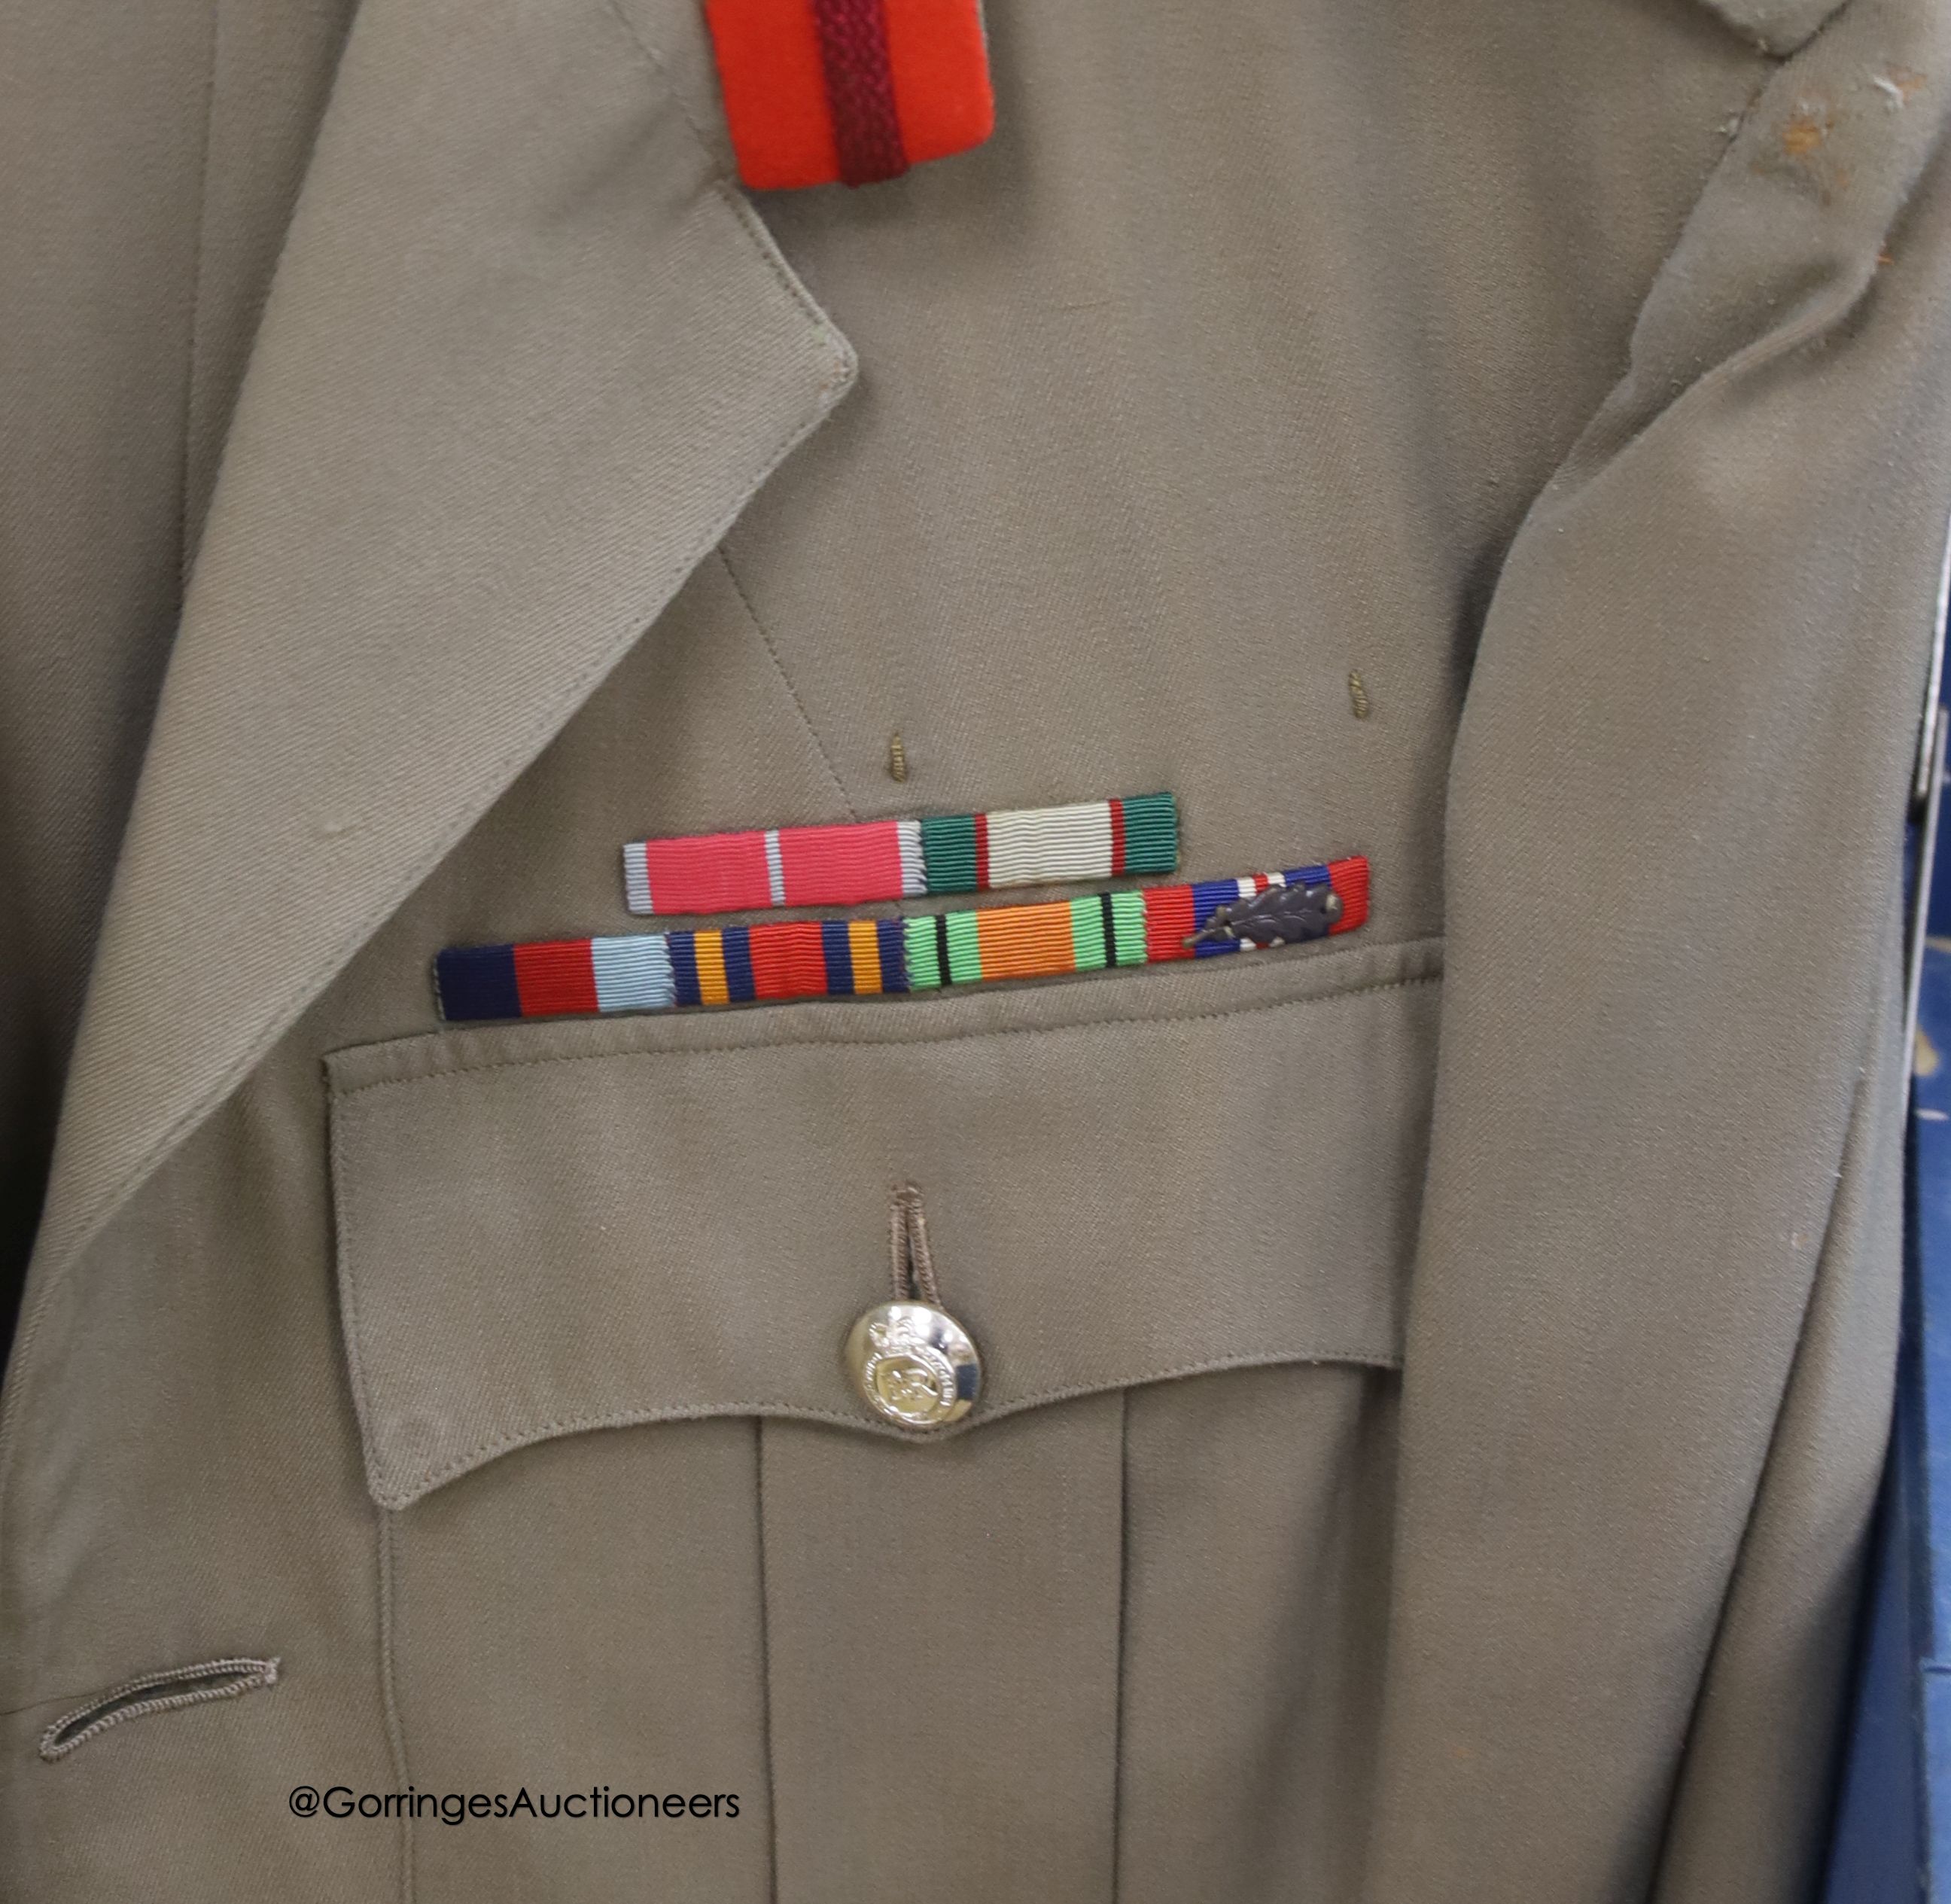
[30,0,853,1280]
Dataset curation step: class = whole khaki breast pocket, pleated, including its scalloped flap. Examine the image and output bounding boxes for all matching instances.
[330,944,1436,1904]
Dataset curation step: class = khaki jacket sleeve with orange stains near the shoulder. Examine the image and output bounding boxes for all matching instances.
[1370,0,1951,1904]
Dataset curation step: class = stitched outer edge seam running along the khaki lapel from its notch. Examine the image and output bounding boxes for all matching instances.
[0,185,853,1590]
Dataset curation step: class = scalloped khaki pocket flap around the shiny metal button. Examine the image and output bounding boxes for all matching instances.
[327,944,1436,1508]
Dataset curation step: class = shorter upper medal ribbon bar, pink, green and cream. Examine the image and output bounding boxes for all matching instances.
[622,794,1179,918]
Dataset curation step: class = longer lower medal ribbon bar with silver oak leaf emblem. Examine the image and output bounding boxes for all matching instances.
[433,858,1368,1022]
